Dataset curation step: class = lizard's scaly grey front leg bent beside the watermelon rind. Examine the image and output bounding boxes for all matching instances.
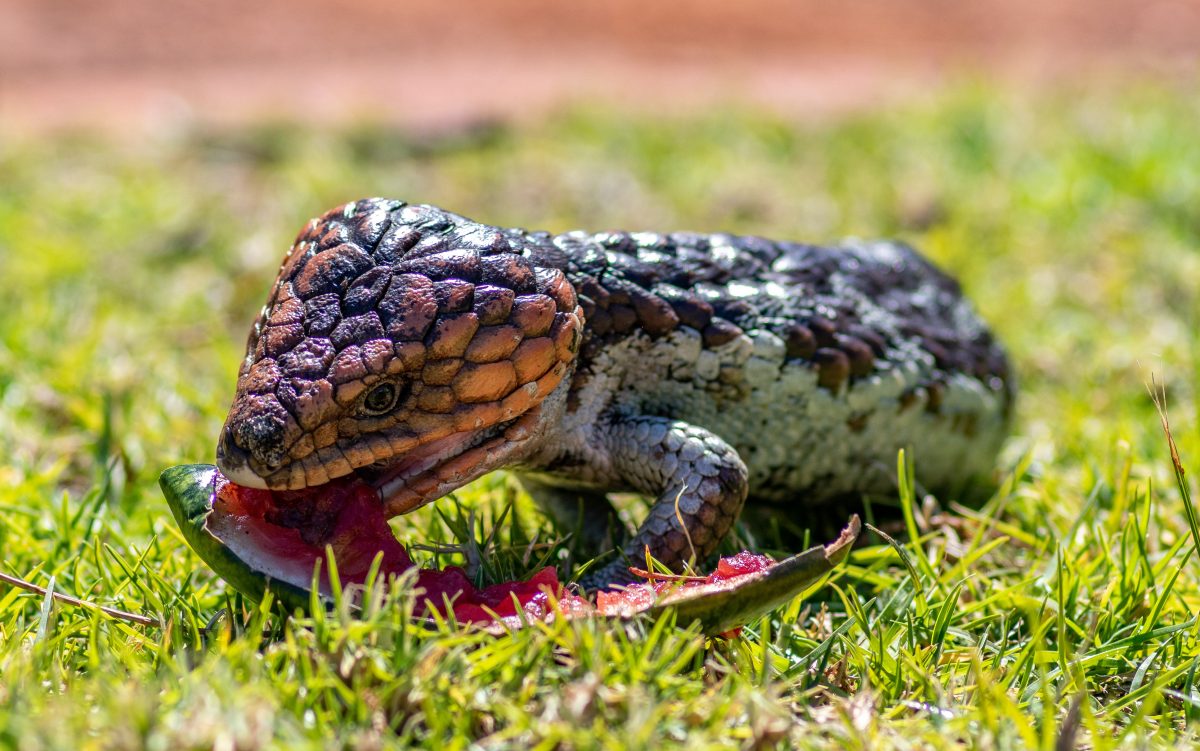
[581,416,749,589]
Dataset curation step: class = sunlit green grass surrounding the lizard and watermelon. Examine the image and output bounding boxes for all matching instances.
[0,79,1200,749]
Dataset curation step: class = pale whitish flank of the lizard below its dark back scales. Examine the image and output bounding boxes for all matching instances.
[551,326,1007,503]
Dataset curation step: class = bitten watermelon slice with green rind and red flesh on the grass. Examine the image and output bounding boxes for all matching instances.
[158,464,858,633]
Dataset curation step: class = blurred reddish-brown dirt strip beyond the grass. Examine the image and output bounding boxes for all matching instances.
[0,0,1200,134]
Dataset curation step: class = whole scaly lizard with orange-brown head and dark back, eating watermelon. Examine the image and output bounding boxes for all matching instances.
[217,199,1013,587]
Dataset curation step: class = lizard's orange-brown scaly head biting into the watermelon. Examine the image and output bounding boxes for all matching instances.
[217,199,583,515]
